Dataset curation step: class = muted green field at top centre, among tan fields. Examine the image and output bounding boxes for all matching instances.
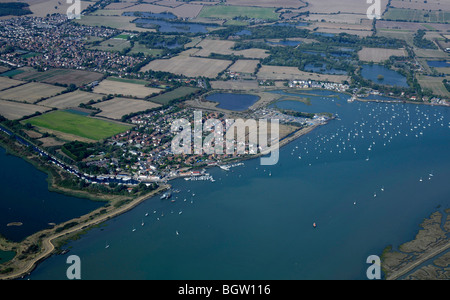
[198,5,278,20]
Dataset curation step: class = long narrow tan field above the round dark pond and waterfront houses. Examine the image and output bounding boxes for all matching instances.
[256,65,349,83]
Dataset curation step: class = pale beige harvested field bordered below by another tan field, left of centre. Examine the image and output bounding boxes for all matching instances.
[94,79,162,98]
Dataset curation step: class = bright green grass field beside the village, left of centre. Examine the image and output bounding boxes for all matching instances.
[26,111,131,140]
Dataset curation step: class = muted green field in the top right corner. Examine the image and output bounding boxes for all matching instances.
[383,8,450,23]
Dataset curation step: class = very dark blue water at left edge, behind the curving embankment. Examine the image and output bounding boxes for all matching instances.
[0,147,103,241]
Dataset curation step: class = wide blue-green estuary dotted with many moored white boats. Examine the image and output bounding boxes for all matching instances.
[24,91,450,279]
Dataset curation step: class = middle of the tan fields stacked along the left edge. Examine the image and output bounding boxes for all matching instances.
[0,82,65,103]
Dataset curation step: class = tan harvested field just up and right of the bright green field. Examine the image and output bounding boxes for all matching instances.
[93,98,161,120]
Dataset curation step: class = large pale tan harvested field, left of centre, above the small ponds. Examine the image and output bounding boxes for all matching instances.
[141,56,231,78]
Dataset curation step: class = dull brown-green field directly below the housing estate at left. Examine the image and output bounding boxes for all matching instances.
[14,69,103,86]
